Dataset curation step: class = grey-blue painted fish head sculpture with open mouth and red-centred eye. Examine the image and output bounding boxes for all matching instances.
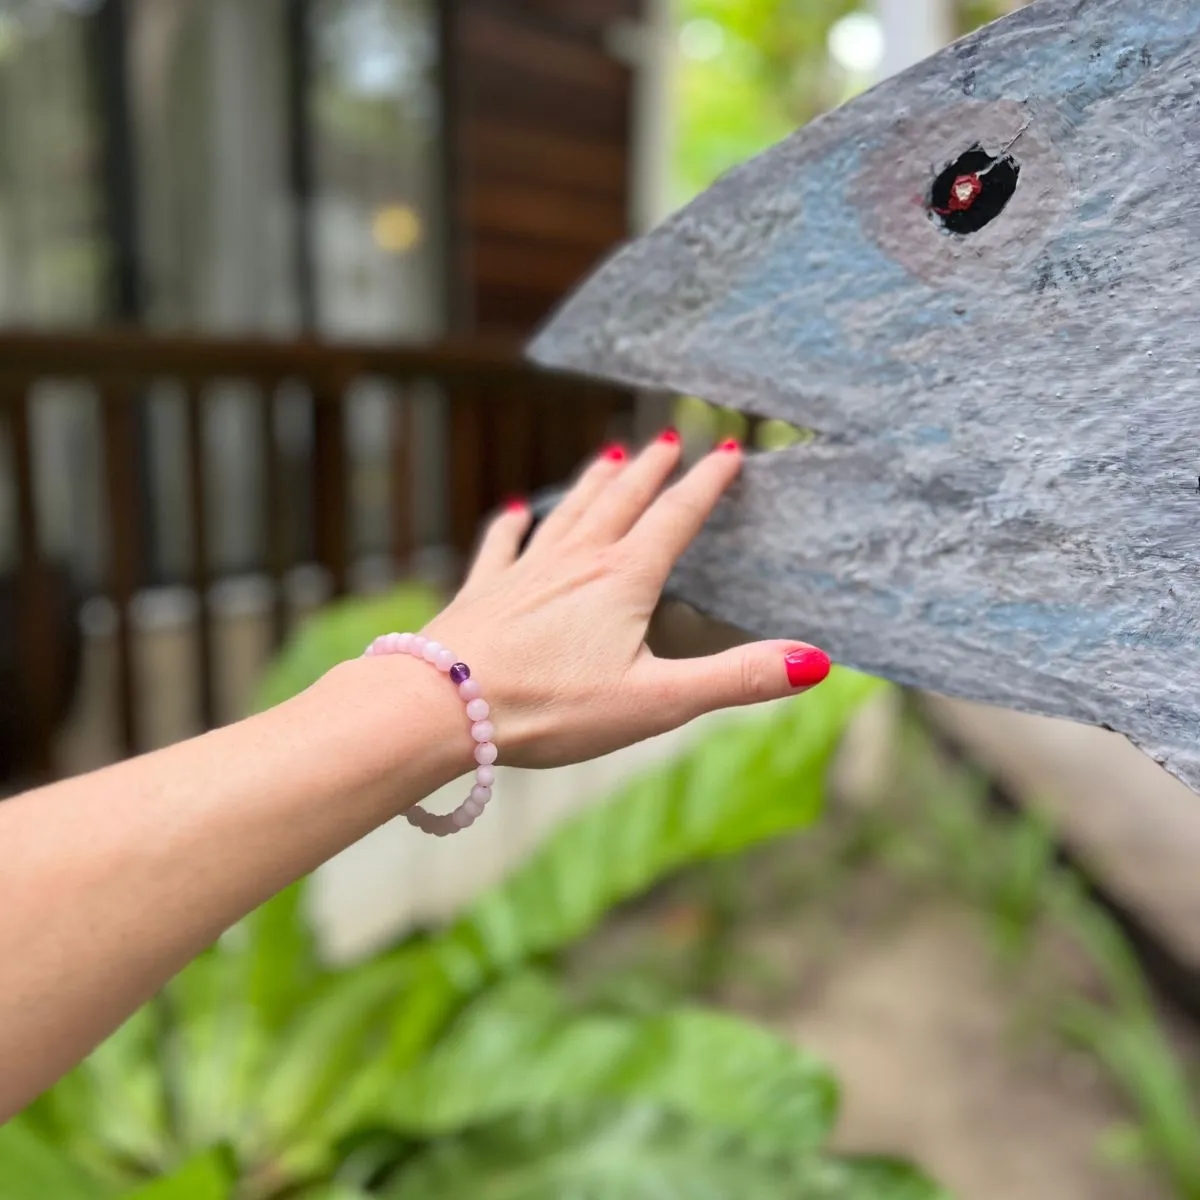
[530,0,1200,791]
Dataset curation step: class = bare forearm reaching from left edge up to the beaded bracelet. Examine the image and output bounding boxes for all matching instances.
[0,660,468,1121]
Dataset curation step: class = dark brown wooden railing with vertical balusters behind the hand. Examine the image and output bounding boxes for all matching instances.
[0,332,631,776]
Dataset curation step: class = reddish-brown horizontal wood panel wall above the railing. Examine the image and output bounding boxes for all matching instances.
[442,0,641,336]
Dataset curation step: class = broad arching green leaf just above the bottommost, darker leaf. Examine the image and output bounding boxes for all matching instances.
[379,976,838,1154]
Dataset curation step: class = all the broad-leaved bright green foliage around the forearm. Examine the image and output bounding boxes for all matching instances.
[0,589,937,1200]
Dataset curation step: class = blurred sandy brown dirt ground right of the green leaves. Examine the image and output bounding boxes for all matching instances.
[578,806,1194,1200]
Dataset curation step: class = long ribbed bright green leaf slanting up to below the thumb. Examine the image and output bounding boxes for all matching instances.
[433,671,881,995]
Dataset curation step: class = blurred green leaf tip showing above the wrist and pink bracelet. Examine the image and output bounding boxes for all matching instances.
[254,583,444,710]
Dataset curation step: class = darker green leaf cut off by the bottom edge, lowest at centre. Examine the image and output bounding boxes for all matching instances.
[383,1108,942,1200]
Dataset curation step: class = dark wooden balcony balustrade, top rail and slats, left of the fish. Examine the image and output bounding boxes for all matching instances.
[0,332,632,786]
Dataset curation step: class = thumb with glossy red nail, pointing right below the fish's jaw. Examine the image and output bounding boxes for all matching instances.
[650,641,829,725]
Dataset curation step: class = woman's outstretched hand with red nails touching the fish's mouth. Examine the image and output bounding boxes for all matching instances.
[424,431,829,767]
